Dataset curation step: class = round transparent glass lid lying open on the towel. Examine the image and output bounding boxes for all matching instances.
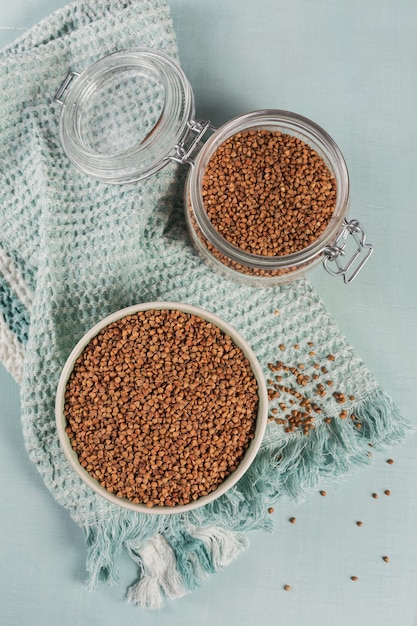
[55,48,195,183]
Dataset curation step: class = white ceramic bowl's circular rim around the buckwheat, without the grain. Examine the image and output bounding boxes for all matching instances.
[55,302,268,514]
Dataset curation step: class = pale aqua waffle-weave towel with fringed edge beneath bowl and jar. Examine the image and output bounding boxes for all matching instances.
[0,0,408,608]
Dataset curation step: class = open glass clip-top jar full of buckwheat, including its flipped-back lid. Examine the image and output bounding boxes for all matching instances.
[55,49,372,286]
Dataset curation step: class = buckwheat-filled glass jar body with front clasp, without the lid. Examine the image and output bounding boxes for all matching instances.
[186,110,371,285]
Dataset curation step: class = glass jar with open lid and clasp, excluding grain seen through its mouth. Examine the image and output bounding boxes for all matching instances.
[55,49,372,286]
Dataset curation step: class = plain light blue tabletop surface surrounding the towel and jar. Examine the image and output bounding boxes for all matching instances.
[0,0,417,626]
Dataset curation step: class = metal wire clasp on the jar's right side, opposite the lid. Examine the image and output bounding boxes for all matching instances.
[323,220,373,284]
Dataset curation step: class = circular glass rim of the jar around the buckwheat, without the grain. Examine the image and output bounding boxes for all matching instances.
[188,109,349,270]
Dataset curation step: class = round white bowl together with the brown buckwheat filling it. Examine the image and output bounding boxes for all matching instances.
[56,302,268,513]
